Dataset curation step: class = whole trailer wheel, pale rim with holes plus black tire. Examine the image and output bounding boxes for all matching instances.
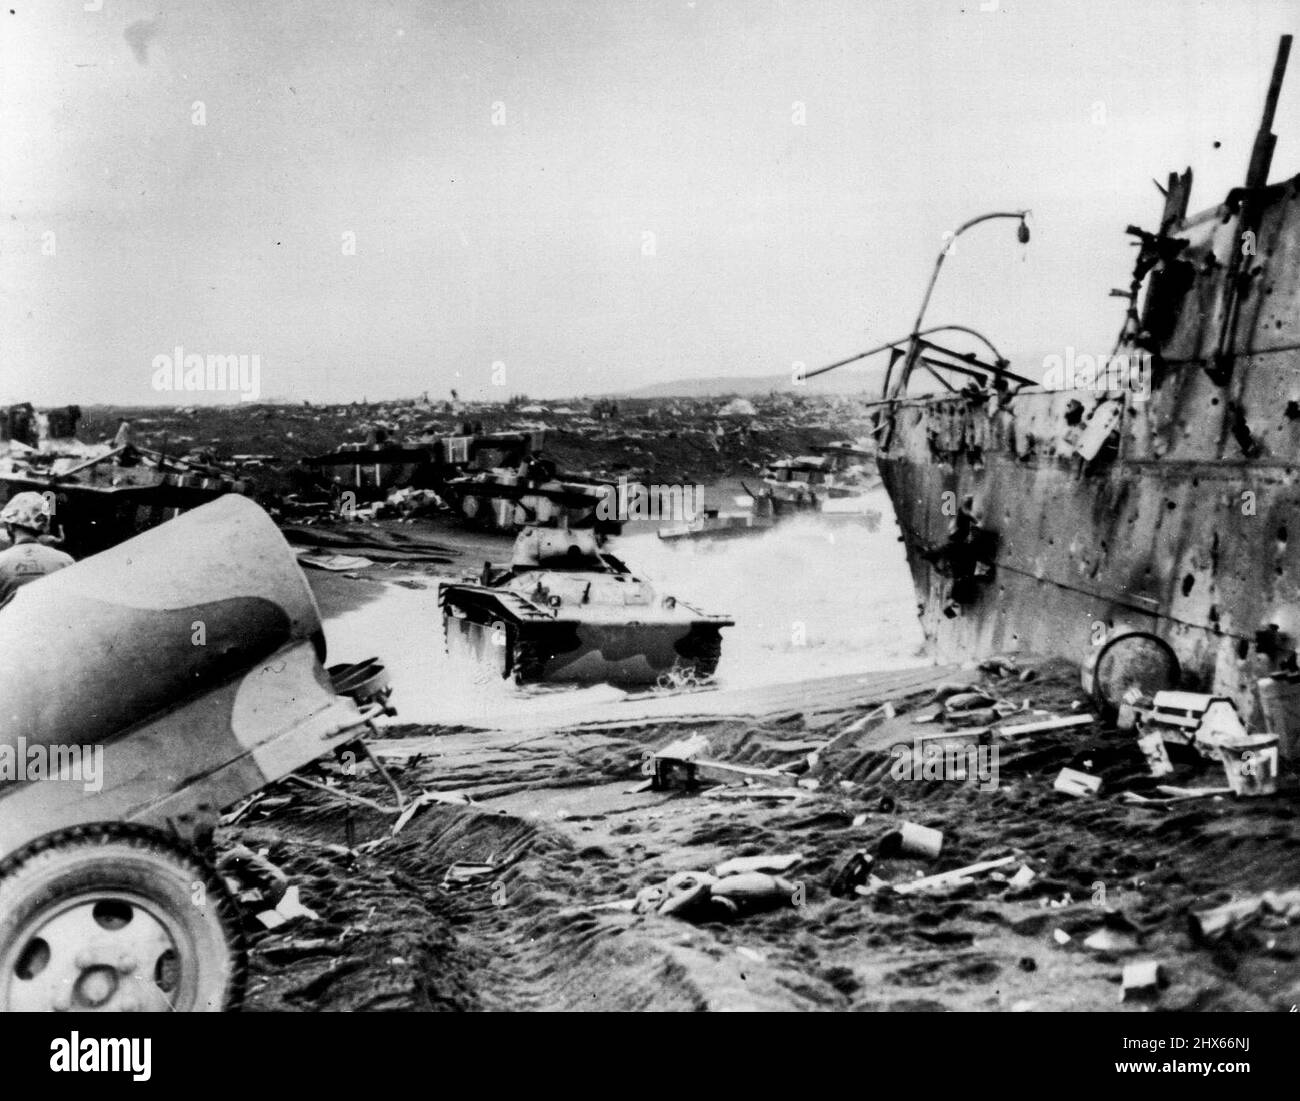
[0,823,247,1013]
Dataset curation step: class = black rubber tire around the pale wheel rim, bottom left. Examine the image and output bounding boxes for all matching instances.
[0,823,248,1013]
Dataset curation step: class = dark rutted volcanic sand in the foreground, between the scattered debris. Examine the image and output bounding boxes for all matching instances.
[222,666,1300,1011]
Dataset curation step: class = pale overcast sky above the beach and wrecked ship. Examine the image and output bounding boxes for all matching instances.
[0,0,1300,404]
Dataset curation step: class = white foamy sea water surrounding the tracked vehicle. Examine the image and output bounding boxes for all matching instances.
[311,489,924,725]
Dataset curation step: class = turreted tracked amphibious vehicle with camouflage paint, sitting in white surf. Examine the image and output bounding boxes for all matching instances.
[438,528,732,685]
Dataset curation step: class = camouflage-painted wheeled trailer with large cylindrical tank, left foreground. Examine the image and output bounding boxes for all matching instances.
[0,494,390,1011]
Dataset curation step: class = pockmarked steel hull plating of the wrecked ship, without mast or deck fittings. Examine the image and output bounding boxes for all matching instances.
[878,201,1300,708]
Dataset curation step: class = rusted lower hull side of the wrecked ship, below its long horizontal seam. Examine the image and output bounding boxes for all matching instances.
[880,382,1300,707]
